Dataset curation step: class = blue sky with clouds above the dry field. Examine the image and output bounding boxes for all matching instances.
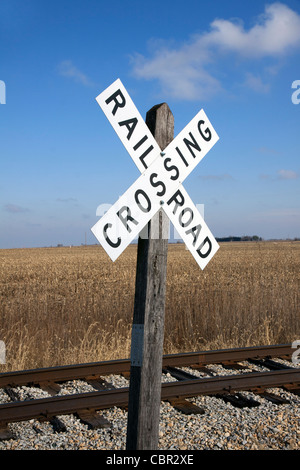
[0,0,300,248]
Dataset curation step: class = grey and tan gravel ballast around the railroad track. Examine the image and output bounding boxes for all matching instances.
[0,365,300,451]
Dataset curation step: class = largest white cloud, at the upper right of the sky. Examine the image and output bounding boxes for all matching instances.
[132,3,300,99]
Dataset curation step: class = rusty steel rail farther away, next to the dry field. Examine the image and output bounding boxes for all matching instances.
[0,344,293,388]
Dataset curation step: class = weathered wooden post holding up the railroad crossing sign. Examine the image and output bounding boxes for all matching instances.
[126,103,174,450]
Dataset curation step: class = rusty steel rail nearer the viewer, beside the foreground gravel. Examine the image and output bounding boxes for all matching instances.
[0,369,300,427]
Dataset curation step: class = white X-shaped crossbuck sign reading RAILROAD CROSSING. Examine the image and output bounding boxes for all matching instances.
[91,79,219,269]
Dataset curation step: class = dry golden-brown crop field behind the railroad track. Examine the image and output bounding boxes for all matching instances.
[0,242,300,372]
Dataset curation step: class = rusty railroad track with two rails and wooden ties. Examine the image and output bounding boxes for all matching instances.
[0,344,300,439]
